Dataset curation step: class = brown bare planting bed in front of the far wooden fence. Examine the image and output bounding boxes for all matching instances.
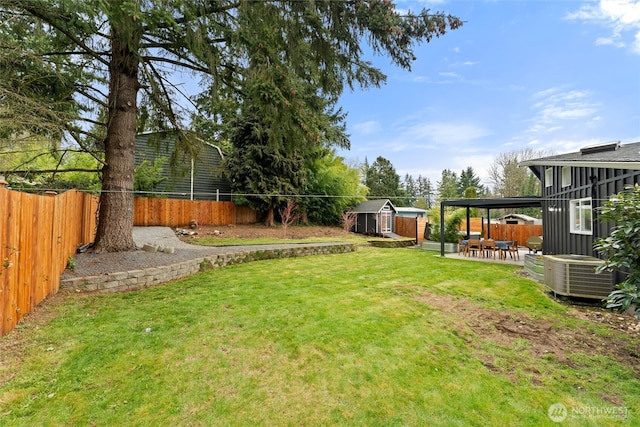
[180,224,346,242]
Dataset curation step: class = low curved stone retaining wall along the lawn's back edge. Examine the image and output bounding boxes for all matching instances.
[60,243,356,292]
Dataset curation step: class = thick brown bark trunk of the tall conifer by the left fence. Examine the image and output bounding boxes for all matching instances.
[95,13,140,252]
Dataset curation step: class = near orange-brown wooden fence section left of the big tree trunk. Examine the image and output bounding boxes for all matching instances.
[0,186,98,336]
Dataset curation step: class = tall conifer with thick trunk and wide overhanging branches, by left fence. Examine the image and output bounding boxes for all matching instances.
[0,0,462,251]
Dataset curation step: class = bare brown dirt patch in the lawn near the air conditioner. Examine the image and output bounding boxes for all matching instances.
[418,292,640,384]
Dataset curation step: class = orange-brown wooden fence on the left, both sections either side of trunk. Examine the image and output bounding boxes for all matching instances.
[0,192,257,336]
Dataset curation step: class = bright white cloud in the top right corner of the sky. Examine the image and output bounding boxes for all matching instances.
[566,0,640,54]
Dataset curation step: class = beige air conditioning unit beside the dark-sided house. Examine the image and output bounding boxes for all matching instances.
[544,255,615,299]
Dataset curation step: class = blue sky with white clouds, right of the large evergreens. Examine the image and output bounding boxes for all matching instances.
[338,0,640,190]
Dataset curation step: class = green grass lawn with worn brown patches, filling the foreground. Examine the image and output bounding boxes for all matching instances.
[0,247,640,426]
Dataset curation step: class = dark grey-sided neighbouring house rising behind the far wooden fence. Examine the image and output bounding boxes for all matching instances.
[135,132,231,201]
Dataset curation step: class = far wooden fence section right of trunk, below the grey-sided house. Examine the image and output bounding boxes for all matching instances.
[133,197,258,227]
